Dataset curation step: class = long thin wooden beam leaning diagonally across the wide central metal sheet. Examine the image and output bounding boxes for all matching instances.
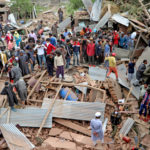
[37,84,63,137]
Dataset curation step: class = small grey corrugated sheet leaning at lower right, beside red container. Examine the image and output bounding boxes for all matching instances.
[120,118,135,136]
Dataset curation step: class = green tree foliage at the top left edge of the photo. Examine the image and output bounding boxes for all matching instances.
[10,0,33,18]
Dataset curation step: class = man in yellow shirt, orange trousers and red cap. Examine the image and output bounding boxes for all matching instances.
[105,53,118,81]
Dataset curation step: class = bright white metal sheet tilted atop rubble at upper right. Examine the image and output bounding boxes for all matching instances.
[112,14,129,27]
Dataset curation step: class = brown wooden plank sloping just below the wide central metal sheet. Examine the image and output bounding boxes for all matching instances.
[54,118,91,136]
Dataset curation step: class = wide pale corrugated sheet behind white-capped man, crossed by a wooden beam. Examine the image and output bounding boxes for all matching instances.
[42,98,106,121]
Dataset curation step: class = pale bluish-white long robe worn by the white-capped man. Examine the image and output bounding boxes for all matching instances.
[90,119,104,142]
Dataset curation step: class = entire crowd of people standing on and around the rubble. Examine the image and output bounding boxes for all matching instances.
[0,9,150,145]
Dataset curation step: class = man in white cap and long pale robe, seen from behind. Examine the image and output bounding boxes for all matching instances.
[90,112,104,146]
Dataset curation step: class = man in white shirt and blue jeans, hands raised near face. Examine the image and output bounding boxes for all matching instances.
[35,40,46,69]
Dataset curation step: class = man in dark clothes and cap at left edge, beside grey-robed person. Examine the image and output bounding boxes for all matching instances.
[1,82,18,112]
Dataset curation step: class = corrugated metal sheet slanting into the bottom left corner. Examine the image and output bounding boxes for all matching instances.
[0,124,35,150]
